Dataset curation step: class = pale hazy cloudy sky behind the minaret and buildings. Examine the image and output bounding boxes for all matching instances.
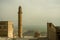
[0,0,60,26]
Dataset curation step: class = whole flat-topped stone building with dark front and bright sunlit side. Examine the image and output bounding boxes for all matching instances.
[0,21,13,38]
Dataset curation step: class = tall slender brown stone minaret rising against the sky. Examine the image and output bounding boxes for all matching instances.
[18,6,22,38]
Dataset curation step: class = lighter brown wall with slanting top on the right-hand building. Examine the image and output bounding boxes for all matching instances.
[47,23,56,40]
